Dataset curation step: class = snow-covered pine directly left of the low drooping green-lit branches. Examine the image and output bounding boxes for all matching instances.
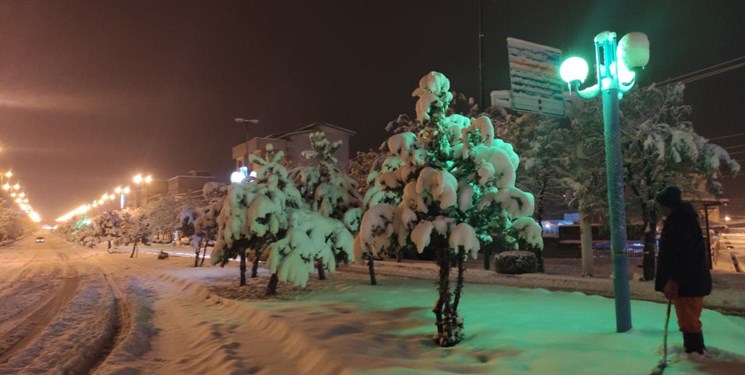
[211,144,304,285]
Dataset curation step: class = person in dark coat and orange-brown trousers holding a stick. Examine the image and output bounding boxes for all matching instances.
[655,186,711,354]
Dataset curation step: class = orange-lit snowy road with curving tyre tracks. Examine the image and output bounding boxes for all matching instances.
[0,235,343,374]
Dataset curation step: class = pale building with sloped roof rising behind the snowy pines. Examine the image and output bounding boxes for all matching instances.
[233,122,357,170]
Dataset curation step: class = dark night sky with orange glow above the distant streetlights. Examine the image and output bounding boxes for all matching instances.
[0,0,745,222]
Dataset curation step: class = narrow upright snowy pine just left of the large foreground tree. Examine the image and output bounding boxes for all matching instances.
[289,132,362,280]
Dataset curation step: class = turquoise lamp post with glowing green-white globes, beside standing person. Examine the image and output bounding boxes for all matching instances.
[560,31,649,332]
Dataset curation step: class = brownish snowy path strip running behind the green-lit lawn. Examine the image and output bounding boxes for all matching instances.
[337,258,745,316]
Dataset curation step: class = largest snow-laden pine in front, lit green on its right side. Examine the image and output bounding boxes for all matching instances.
[354,72,543,346]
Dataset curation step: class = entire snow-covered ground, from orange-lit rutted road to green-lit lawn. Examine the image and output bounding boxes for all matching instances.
[0,235,745,374]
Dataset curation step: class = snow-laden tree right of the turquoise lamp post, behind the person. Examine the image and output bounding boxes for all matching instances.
[621,84,740,280]
